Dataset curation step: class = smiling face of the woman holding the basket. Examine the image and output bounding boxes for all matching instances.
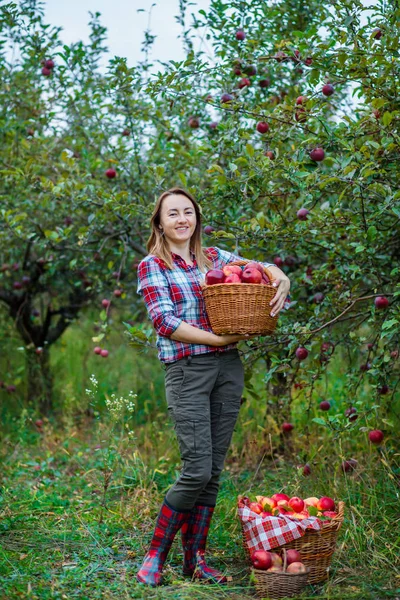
[160,194,197,246]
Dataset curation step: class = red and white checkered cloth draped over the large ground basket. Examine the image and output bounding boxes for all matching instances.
[238,501,322,554]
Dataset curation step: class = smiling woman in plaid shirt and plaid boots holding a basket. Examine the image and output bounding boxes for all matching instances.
[137,188,290,586]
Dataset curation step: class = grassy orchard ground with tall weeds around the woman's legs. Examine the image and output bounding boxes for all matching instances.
[0,320,400,600]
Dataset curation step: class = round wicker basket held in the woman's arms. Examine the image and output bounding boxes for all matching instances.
[203,260,278,335]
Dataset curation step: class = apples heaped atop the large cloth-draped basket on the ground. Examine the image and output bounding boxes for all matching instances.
[243,494,337,519]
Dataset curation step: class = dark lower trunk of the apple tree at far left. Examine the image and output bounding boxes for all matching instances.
[26,348,53,415]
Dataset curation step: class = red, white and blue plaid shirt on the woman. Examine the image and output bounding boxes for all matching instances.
[137,247,274,363]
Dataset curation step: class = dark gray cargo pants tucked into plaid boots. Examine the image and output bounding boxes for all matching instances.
[165,349,244,511]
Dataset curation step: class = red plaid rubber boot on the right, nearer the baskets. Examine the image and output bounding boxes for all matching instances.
[181,505,227,583]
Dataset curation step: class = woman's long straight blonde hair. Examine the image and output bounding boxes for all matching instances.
[147,187,213,272]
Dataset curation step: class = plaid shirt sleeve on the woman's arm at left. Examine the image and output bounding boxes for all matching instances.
[137,259,182,337]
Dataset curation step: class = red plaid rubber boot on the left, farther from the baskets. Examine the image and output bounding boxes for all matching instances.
[136,500,190,587]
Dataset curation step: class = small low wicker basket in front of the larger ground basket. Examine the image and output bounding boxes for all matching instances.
[253,568,310,599]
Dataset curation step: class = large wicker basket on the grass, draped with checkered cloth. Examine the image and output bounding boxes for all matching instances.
[239,496,344,584]
